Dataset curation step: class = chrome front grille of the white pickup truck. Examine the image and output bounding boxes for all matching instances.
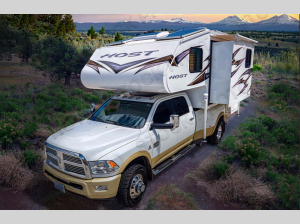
[46,143,91,179]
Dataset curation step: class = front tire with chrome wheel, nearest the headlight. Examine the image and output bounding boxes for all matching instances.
[117,164,147,207]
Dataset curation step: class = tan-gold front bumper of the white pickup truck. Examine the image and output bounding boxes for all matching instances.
[43,162,121,199]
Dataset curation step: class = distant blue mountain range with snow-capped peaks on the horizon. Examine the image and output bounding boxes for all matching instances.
[75,14,299,31]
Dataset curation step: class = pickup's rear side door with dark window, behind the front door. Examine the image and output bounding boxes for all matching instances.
[172,96,196,147]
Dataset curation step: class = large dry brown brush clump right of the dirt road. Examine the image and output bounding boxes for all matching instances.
[188,154,275,208]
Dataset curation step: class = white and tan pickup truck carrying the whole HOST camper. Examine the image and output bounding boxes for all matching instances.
[43,29,256,206]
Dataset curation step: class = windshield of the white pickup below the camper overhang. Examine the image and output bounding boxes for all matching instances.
[90,99,152,128]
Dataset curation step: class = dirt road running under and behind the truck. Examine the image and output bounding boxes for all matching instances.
[0,99,257,210]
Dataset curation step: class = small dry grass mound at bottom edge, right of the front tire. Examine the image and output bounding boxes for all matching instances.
[146,184,198,210]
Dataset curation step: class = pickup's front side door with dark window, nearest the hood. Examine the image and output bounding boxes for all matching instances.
[149,100,177,166]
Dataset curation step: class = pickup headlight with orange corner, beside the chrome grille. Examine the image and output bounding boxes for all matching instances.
[90,160,119,176]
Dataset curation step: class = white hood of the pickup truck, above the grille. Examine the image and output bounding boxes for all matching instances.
[47,120,140,161]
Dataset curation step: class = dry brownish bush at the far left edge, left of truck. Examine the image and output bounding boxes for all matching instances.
[0,150,34,189]
